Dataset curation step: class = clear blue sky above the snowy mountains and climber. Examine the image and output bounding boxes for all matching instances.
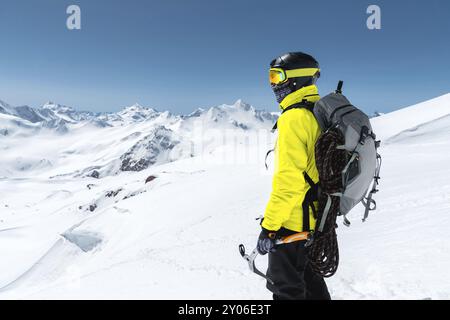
[0,0,450,113]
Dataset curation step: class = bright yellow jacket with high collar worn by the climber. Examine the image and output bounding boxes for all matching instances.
[262,85,321,232]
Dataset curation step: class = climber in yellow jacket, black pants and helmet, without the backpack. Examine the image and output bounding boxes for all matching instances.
[257,52,331,300]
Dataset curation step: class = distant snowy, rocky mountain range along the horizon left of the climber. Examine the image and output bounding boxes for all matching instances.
[0,100,277,178]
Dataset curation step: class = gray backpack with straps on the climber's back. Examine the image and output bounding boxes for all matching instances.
[313,81,381,231]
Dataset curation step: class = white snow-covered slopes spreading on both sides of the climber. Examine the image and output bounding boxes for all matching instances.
[0,96,450,299]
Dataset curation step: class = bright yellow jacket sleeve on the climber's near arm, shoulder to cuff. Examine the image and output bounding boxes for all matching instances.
[262,110,308,231]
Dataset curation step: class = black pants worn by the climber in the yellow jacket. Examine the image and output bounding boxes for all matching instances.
[267,230,331,300]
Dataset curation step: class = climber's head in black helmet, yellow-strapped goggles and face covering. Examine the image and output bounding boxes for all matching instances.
[270,52,320,103]
